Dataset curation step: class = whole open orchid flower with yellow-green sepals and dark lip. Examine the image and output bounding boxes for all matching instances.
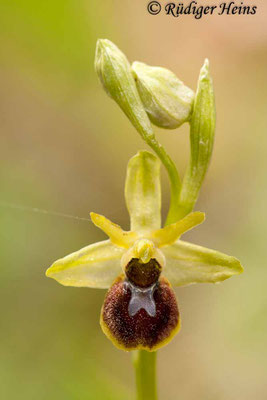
[46,151,243,351]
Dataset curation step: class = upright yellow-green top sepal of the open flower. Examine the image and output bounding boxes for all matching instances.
[125,151,161,232]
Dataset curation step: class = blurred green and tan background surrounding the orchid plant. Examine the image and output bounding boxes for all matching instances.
[0,0,267,400]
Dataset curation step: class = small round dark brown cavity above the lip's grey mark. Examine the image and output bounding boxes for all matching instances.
[125,258,161,287]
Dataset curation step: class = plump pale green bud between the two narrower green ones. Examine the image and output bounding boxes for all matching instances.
[132,62,194,129]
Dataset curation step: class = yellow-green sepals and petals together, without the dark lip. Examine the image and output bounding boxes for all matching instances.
[46,151,243,288]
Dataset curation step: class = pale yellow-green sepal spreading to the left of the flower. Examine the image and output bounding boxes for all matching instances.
[46,240,125,289]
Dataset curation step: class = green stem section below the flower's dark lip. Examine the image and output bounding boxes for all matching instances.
[133,350,158,400]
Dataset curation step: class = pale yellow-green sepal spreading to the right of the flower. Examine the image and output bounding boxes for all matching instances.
[161,240,243,286]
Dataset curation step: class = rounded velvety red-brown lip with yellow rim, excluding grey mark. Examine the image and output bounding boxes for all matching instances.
[102,277,179,350]
